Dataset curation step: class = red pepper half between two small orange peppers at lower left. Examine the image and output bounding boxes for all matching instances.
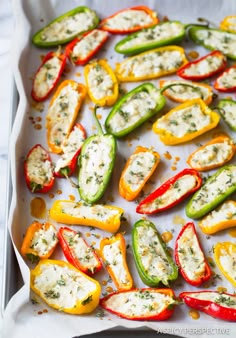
[57,227,102,276]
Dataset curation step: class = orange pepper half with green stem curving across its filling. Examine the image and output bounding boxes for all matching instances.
[159,80,213,105]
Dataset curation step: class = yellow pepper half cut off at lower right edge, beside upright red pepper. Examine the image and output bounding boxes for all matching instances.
[214,242,236,287]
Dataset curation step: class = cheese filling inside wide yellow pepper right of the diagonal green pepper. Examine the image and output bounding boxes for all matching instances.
[157,104,211,138]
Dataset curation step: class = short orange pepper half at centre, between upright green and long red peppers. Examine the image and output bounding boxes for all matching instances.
[119,146,160,201]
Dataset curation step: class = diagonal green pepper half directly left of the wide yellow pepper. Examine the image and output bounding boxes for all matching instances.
[105,82,166,137]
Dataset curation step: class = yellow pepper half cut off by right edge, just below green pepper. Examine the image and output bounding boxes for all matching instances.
[198,200,236,235]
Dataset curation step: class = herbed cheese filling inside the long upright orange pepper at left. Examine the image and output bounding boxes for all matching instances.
[47,84,80,146]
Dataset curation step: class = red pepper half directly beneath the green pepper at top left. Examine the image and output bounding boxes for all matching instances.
[66,29,109,65]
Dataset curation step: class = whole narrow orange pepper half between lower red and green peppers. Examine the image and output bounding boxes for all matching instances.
[100,233,134,291]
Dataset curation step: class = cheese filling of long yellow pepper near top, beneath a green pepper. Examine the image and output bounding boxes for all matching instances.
[119,50,184,78]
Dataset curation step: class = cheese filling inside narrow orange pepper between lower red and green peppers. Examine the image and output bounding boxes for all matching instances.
[103,241,129,285]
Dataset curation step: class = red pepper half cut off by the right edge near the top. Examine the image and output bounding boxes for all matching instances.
[214,65,236,93]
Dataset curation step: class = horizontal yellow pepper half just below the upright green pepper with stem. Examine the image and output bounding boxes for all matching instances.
[50,200,124,233]
